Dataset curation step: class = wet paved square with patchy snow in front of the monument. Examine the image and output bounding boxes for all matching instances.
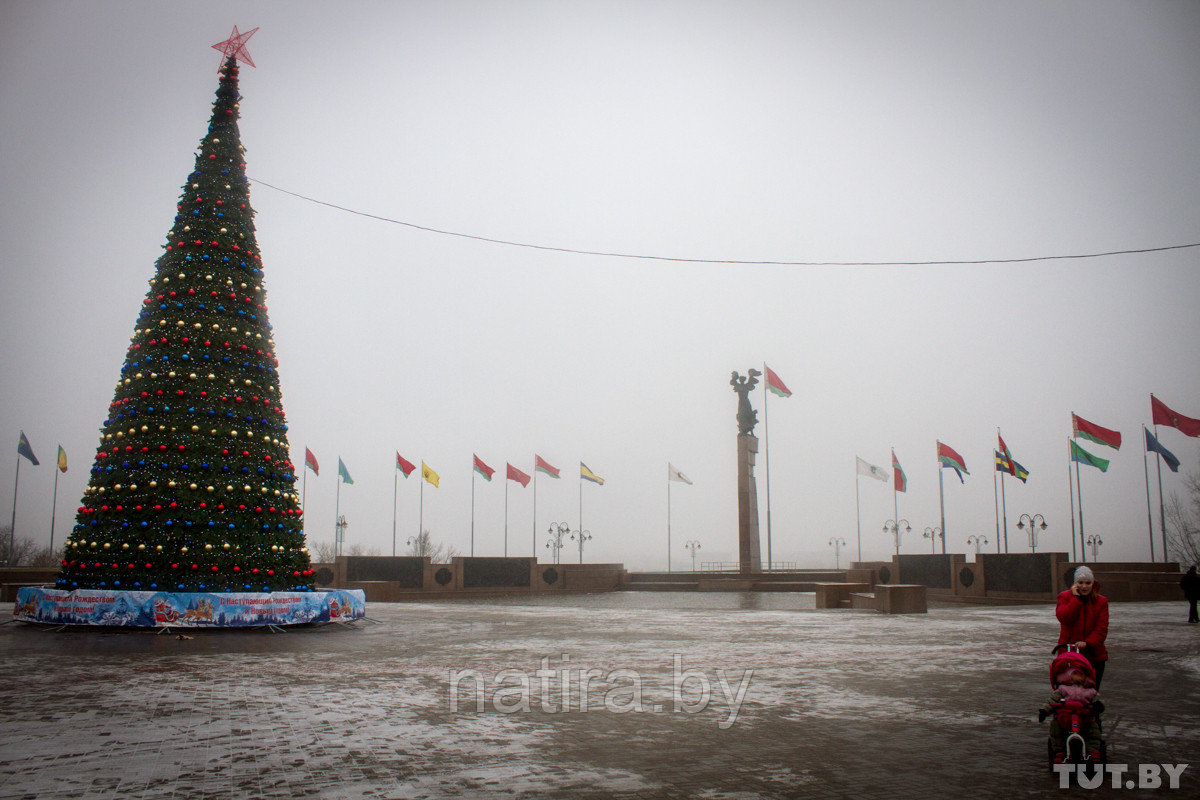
[0,593,1200,800]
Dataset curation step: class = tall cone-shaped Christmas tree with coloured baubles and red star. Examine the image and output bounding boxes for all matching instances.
[58,40,313,593]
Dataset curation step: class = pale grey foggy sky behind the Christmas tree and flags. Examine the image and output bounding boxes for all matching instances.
[0,0,1200,569]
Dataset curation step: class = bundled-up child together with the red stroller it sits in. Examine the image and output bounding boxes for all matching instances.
[1038,645,1106,766]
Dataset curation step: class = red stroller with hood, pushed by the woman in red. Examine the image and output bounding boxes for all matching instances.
[1038,644,1108,770]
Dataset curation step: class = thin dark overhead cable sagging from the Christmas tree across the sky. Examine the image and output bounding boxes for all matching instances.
[247,176,1200,266]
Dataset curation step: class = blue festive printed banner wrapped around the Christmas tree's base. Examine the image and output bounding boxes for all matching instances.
[13,587,366,628]
